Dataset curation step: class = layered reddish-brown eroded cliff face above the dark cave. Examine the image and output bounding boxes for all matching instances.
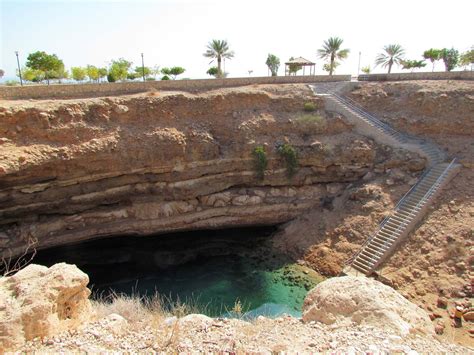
[0,85,424,256]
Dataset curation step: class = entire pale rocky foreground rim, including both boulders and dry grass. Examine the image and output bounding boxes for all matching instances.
[0,264,473,354]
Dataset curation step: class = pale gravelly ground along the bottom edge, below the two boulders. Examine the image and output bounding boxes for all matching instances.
[20,315,474,354]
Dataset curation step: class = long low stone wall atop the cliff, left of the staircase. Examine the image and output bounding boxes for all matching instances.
[0,75,351,99]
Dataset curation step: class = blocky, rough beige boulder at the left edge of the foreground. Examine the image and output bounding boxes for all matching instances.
[0,263,92,349]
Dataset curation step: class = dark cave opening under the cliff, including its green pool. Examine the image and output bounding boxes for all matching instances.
[30,226,321,318]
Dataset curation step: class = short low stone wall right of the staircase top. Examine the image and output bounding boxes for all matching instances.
[357,71,474,81]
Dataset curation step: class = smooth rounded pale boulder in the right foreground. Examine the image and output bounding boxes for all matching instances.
[303,276,434,335]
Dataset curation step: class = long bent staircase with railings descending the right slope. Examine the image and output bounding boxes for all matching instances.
[311,83,460,276]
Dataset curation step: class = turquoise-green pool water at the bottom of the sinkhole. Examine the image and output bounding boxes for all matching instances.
[96,255,317,317]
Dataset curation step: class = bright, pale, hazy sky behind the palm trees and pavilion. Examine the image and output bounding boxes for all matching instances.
[0,0,474,81]
